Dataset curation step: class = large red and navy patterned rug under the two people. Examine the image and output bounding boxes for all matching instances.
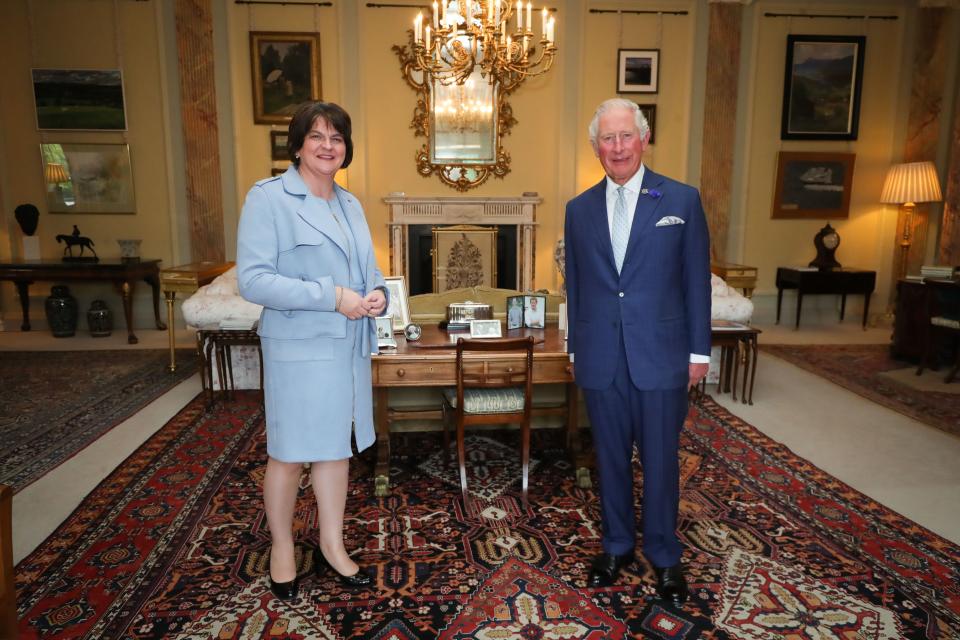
[16,392,960,640]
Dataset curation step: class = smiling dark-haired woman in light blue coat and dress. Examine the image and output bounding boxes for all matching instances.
[237,102,387,600]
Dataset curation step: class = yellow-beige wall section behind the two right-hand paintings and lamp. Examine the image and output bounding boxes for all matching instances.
[744,2,905,302]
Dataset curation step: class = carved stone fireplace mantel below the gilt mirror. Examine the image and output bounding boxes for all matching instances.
[383,192,543,291]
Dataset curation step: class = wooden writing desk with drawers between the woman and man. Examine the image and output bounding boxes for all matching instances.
[373,325,590,496]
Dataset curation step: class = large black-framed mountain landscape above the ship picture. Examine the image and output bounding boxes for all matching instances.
[780,35,867,140]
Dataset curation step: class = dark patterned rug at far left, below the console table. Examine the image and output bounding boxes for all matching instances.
[0,349,197,491]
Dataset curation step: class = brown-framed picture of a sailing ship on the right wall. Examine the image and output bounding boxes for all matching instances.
[771,151,856,220]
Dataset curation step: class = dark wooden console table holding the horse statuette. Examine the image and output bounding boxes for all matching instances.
[0,260,167,344]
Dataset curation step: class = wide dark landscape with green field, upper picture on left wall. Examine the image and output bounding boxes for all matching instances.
[32,69,127,131]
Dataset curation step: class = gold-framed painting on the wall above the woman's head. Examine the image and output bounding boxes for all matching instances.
[250,31,321,124]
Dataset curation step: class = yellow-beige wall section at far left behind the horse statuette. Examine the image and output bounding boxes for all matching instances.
[0,0,171,329]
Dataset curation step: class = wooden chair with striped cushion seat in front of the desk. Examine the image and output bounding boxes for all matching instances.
[443,336,535,507]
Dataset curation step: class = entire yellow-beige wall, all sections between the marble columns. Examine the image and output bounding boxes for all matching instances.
[0,0,957,329]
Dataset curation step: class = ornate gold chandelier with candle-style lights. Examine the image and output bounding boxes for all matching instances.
[411,0,557,93]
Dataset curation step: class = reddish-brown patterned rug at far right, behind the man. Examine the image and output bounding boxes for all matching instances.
[760,344,960,436]
